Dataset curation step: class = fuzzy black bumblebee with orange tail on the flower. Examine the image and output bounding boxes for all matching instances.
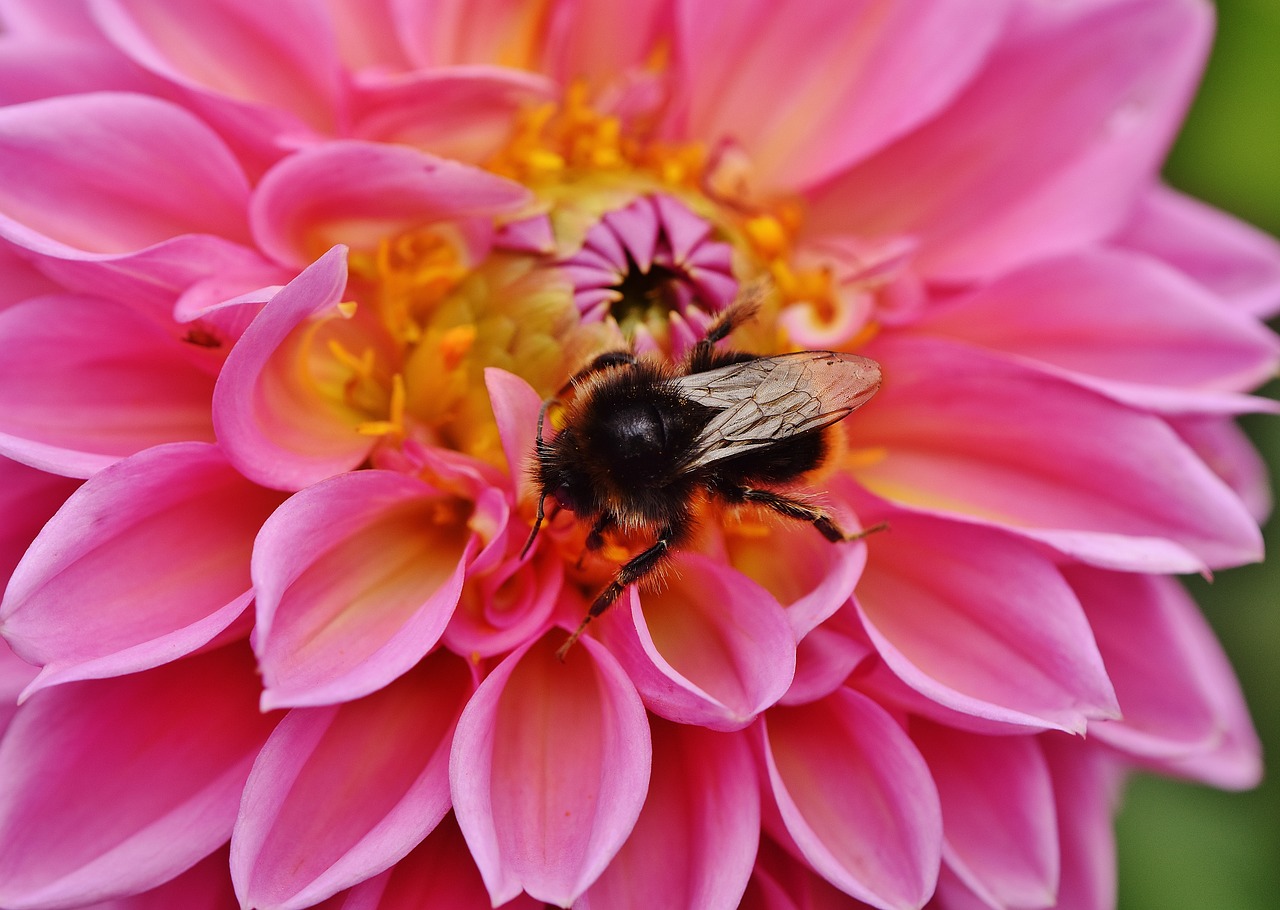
[521,305,881,659]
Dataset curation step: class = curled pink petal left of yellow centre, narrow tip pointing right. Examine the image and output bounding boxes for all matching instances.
[250,141,530,266]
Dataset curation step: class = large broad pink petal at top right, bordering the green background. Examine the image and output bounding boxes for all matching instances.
[806,0,1212,280]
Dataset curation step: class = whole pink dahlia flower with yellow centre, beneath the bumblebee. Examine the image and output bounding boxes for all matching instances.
[0,0,1280,910]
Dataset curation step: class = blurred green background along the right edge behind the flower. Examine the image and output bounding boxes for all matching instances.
[1119,0,1280,910]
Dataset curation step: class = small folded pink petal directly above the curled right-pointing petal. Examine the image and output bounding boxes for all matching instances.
[355,67,554,164]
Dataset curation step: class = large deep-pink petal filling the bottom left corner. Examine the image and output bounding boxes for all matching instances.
[0,648,275,910]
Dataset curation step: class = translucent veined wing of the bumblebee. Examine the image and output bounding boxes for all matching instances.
[673,351,881,470]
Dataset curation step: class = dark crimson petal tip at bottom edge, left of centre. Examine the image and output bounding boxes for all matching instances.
[335,815,547,910]
